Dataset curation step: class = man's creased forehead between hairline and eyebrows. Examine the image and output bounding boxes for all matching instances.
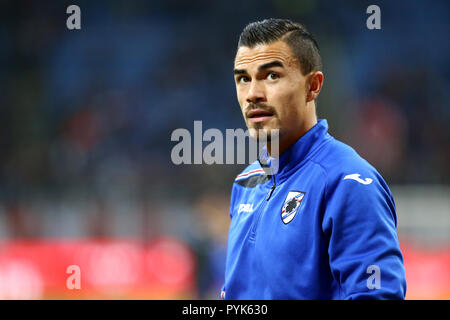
[234,41,298,69]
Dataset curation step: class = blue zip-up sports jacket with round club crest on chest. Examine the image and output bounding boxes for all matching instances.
[222,119,406,300]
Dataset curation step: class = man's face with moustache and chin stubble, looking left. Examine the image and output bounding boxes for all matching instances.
[234,41,307,140]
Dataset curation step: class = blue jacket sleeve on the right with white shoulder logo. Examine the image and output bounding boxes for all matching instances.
[322,169,406,299]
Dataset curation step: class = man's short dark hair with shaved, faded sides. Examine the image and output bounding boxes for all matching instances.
[238,19,322,75]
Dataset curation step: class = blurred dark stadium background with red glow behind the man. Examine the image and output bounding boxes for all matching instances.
[0,0,450,299]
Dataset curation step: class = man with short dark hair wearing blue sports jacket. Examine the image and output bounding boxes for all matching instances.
[222,19,406,300]
